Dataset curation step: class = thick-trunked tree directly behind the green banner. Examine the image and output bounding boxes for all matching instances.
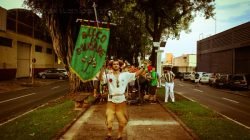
[24,0,113,93]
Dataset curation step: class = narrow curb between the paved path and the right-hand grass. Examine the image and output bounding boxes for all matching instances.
[158,100,199,140]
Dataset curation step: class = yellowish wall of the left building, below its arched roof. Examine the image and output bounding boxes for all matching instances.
[0,31,58,79]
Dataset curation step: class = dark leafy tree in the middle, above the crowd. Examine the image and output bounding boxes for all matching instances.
[106,1,150,65]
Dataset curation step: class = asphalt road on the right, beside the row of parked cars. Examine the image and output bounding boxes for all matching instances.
[175,80,250,129]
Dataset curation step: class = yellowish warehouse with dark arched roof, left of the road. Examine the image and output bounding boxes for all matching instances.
[0,7,62,80]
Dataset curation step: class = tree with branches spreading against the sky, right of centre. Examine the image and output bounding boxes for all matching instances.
[135,0,214,65]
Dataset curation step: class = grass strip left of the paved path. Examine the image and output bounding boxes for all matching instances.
[0,99,79,140]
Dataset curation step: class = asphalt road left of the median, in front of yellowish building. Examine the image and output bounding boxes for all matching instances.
[0,81,69,122]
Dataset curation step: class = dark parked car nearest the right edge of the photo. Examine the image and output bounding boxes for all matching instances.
[228,74,248,90]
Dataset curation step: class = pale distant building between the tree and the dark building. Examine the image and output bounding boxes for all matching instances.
[174,54,196,72]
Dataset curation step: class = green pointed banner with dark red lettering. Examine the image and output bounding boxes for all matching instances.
[71,25,110,81]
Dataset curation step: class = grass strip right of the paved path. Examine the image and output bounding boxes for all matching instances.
[158,88,250,140]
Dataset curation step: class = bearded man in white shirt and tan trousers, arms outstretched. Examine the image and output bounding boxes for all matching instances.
[100,60,144,140]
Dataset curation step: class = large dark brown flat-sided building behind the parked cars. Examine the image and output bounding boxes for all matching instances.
[197,22,250,74]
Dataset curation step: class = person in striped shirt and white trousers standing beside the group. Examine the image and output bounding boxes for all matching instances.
[162,67,175,102]
